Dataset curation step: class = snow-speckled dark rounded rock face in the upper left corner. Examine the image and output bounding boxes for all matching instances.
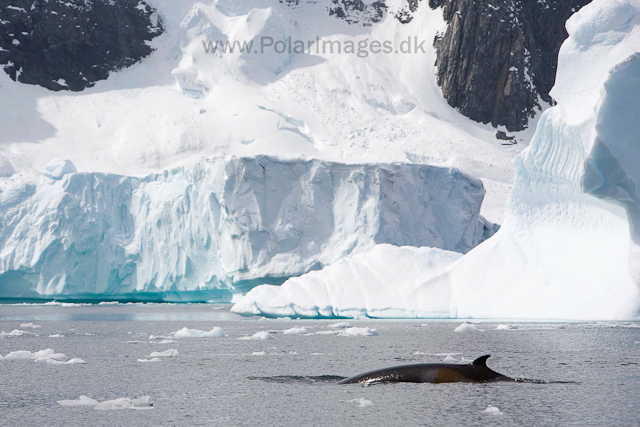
[0,0,163,91]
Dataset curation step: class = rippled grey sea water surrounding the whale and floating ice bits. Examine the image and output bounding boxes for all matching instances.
[0,305,640,426]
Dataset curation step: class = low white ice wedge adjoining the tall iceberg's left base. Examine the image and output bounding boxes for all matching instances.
[231,244,461,318]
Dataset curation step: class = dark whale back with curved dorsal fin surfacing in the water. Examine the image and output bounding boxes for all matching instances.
[338,354,515,384]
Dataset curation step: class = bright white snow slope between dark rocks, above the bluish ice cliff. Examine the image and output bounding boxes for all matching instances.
[0,0,520,222]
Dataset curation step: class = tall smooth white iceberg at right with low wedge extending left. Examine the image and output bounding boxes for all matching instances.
[232,0,640,320]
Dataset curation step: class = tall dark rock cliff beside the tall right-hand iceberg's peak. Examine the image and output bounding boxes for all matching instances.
[429,0,591,131]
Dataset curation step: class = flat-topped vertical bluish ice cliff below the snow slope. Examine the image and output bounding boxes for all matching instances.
[0,156,484,301]
